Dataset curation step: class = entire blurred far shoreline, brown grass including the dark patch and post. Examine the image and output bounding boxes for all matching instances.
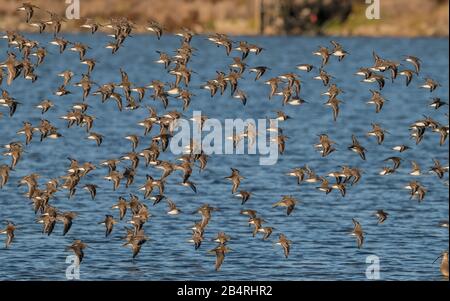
[0,0,449,37]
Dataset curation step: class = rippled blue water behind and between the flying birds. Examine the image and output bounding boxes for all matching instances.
[0,34,449,280]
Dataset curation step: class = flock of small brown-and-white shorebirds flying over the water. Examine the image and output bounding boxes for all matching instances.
[0,3,449,277]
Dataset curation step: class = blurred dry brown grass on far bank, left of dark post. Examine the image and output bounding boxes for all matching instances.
[0,0,255,34]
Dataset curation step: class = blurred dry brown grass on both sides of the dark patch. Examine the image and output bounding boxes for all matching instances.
[0,0,449,36]
